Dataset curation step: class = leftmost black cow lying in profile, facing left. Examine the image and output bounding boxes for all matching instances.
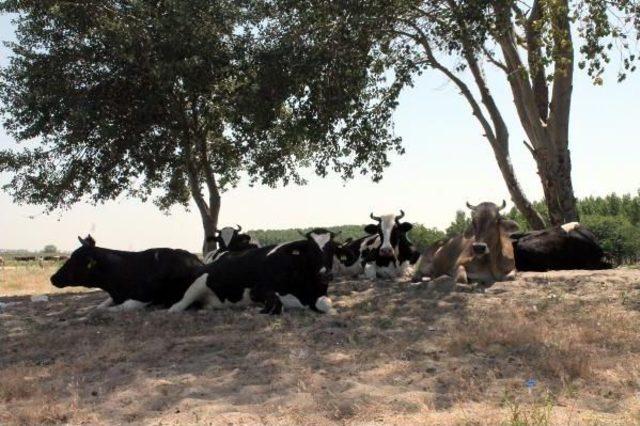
[51,235,203,311]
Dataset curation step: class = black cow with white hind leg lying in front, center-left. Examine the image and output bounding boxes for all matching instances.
[169,229,336,315]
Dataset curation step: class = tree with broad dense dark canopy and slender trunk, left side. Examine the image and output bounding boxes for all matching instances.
[0,0,399,252]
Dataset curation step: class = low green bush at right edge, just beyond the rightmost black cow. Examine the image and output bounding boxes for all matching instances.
[582,215,640,264]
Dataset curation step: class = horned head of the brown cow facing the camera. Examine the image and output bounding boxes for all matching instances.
[467,200,517,257]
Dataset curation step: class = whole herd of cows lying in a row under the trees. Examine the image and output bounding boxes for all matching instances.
[51,202,609,314]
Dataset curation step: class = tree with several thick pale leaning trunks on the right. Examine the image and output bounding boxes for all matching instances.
[273,0,640,229]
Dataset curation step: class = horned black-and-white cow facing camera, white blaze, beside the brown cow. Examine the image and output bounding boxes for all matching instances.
[334,210,420,279]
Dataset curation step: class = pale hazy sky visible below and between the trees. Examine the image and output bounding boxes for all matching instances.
[0,15,640,251]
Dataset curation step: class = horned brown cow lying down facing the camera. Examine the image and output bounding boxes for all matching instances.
[414,200,518,285]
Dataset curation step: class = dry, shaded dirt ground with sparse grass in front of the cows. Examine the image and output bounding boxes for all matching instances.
[0,269,640,425]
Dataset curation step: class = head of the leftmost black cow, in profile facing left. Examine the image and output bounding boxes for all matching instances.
[51,235,100,288]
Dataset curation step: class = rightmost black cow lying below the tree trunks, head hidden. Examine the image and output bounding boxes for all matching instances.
[511,222,611,271]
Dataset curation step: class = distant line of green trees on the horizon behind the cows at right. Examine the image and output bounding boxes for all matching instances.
[249,190,640,263]
